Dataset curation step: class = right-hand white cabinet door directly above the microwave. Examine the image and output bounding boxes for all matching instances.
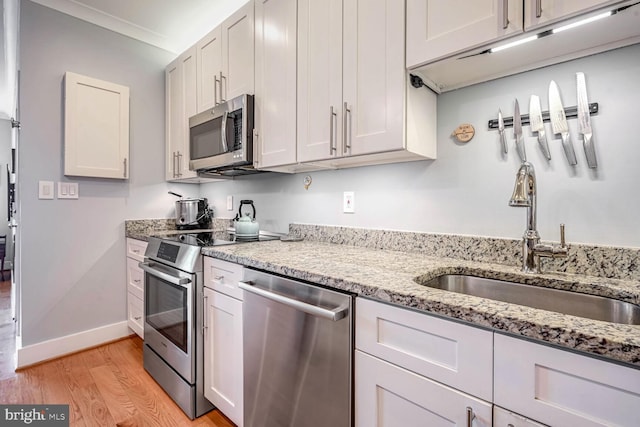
[220,1,254,101]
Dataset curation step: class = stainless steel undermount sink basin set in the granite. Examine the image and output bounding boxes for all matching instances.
[421,274,640,325]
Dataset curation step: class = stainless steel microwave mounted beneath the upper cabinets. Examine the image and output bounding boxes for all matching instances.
[189,95,254,171]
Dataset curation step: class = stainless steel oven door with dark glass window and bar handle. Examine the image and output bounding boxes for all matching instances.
[140,261,196,384]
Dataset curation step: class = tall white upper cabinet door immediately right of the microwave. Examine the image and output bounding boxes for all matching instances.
[254,0,297,169]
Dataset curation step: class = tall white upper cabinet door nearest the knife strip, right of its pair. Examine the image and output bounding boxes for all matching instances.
[342,0,405,155]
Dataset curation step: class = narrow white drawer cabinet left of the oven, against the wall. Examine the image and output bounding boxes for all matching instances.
[127,238,147,339]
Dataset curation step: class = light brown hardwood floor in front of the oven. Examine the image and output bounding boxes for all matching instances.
[0,282,234,427]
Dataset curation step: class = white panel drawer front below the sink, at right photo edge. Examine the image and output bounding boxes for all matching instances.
[494,334,640,427]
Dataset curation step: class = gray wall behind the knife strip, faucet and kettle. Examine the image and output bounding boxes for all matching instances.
[201,45,640,247]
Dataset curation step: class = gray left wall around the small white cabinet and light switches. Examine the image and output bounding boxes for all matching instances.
[18,1,197,345]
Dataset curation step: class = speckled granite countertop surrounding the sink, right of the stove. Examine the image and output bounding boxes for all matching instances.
[203,241,640,368]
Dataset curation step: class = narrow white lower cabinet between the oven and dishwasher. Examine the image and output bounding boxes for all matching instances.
[204,257,243,427]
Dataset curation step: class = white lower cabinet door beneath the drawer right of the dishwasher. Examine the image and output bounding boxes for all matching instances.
[355,350,491,427]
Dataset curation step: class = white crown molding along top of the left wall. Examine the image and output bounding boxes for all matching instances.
[31,0,179,53]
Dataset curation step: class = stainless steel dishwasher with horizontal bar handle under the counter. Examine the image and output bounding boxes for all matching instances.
[240,269,354,427]
